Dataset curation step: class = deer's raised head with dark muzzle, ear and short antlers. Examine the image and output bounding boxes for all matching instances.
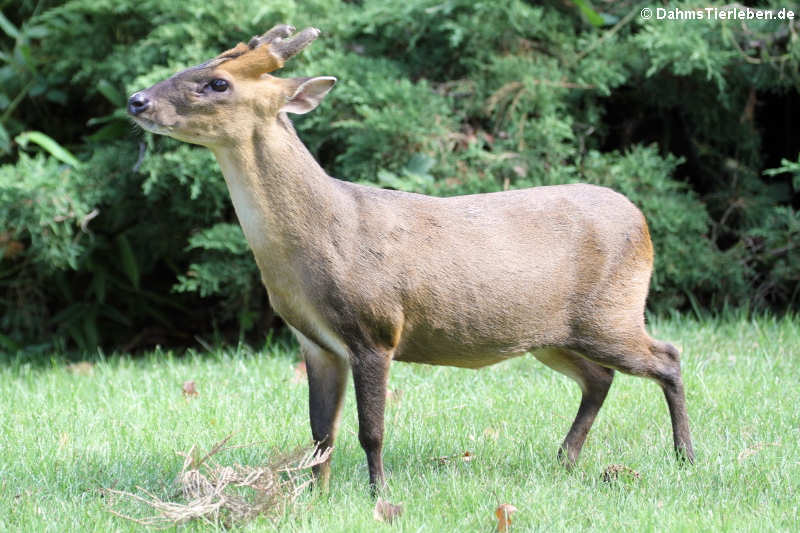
[128,24,336,147]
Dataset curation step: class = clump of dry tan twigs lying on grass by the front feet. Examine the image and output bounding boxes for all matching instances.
[104,435,331,529]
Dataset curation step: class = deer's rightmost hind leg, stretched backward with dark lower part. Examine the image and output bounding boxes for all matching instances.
[580,328,694,463]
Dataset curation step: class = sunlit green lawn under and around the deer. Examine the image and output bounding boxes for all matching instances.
[0,318,800,532]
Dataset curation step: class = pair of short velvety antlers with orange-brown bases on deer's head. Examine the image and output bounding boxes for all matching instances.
[217,24,320,77]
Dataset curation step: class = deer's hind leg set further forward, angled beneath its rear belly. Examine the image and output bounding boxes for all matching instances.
[533,348,614,469]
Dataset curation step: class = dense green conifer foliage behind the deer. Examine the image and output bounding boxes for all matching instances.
[0,0,800,349]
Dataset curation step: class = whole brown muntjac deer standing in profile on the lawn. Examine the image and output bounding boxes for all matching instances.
[128,25,694,488]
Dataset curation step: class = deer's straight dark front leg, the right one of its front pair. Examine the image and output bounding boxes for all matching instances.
[351,349,391,494]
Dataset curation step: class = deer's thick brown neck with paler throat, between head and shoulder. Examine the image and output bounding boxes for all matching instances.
[211,114,343,289]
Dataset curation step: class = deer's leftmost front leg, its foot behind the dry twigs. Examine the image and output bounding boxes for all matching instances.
[301,342,348,490]
